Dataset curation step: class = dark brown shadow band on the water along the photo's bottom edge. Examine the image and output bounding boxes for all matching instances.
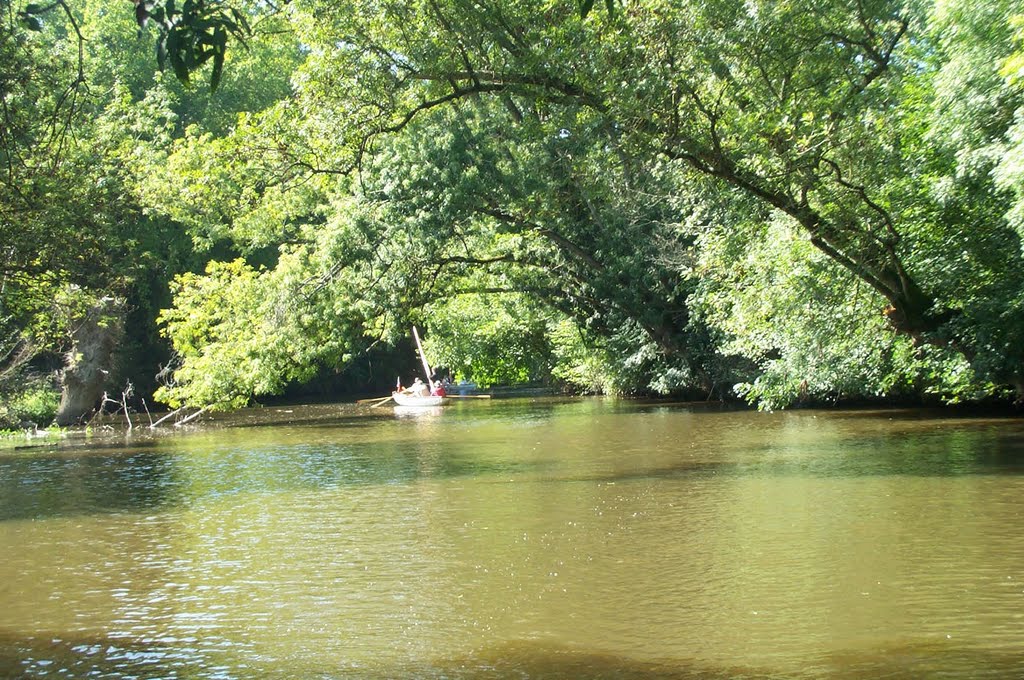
[0,633,1024,680]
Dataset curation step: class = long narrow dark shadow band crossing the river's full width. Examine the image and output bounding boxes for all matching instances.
[0,439,1024,521]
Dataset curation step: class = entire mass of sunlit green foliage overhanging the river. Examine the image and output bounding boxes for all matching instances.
[12,0,1024,408]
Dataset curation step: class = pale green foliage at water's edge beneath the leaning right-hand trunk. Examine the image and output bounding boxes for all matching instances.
[695,209,995,410]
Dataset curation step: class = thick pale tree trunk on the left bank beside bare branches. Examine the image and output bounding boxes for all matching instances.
[56,297,125,427]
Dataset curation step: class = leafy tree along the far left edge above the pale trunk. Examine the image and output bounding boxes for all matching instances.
[0,3,148,420]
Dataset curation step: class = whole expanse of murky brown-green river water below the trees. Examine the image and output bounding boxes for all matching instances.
[0,399,1024,679]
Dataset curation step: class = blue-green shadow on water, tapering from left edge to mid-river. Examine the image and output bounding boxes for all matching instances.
[0,440,557,521]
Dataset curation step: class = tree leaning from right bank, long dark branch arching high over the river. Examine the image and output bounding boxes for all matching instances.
[256,2,1024,399]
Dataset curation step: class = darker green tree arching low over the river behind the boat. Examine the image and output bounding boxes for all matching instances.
[151,73,733,402]
